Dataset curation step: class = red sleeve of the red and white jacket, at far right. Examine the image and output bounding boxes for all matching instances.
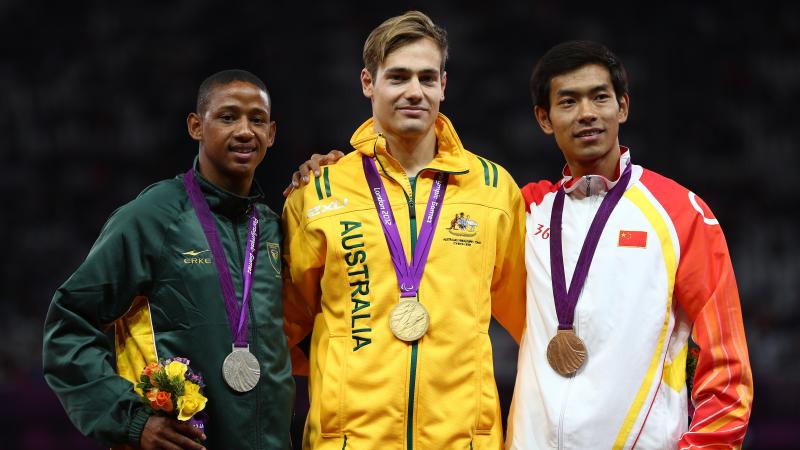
[643,171,753,449]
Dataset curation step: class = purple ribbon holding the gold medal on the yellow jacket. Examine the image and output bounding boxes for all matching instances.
[361,157,448,297]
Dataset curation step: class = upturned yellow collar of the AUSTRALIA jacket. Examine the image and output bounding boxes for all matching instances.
[350,113,469,174]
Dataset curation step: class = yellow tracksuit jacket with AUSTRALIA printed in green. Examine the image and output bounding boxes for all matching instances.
[283,115,525,450]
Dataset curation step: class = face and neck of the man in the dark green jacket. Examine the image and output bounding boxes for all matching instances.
[186,81,276,196]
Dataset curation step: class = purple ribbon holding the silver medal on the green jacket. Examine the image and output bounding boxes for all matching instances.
[183,169,258,347]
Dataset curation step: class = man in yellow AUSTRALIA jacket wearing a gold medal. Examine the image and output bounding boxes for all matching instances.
[283,11,525,450]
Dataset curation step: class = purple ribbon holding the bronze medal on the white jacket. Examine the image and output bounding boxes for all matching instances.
[550,163,631,330]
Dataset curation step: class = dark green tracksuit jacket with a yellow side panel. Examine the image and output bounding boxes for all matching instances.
[43,166,294,450]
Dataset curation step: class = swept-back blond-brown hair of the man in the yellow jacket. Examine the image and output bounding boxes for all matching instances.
[363,11,447,77]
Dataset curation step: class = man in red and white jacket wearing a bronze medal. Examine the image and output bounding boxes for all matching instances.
[507,41,753,450]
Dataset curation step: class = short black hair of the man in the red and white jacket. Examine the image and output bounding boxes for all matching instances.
[530,41,628,111]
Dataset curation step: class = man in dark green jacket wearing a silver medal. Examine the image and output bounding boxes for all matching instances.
[43,70,294,450]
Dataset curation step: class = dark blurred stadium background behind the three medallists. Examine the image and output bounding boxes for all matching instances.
[0,0,800,450]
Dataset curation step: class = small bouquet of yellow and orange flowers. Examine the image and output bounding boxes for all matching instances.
[136,358,208,429]
